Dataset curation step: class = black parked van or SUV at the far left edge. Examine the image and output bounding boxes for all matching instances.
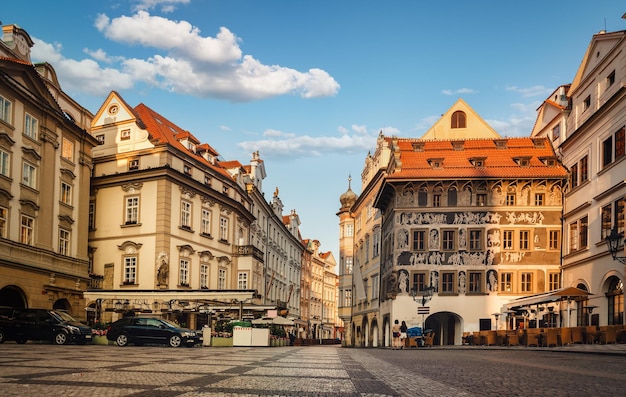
[2,309,91,345]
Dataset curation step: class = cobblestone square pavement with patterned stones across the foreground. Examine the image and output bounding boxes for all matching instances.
[0,343,626,397]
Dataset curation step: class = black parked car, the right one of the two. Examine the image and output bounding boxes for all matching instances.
[107,317,200,347]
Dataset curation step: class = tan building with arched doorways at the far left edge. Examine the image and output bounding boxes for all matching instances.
[0,25,96,319]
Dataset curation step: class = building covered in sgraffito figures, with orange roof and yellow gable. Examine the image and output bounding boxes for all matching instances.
[372,100,567,346]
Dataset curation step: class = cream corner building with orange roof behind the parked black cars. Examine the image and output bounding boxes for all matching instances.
[85,92,258,328]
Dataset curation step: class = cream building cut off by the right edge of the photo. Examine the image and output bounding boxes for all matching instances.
[548,27,626,325]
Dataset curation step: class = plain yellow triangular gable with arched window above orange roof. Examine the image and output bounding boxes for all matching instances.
[422,99,500,140]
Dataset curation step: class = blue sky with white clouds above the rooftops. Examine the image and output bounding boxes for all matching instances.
[0,0,626,261]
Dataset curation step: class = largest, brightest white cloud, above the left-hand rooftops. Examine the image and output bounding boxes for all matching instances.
[86,11,340,102]
